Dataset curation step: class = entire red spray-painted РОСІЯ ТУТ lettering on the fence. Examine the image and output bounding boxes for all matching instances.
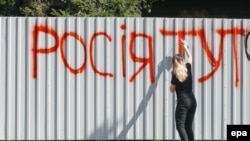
[32,25,247,87]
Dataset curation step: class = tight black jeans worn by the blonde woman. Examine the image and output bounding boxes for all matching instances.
[175,92,197,141]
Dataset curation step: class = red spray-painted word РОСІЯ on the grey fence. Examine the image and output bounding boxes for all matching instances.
[32,25,154,83]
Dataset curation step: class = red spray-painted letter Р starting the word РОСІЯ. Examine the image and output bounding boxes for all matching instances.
[32,25,59,78]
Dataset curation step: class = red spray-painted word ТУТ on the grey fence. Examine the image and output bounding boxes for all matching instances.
[160,27,247,87]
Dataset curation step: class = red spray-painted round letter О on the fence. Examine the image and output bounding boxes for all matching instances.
[60,32,87,74]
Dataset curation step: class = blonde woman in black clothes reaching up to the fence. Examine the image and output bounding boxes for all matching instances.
[170,40,197,141]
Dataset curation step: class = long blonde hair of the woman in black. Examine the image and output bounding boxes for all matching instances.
[172,55,188,82]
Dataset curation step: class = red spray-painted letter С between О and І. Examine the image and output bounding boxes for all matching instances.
[90,32,113,77]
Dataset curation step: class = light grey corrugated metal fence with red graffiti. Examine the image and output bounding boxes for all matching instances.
[0,17,250,140]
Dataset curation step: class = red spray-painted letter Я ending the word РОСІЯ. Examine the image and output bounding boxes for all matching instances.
[129,32,154,83]
